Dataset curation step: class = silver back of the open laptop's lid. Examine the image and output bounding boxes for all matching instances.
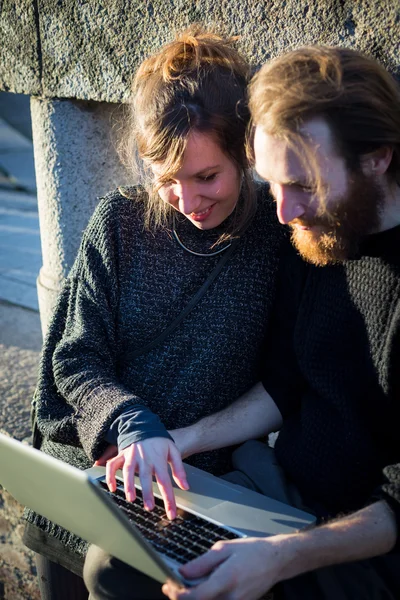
[0,433,179,583]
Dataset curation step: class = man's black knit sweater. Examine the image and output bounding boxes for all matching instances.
[263,226,400,514]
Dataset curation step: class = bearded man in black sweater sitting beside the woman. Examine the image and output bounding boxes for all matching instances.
[159,47,400,600]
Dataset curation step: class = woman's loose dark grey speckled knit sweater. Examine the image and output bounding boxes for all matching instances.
[28,186,283,556]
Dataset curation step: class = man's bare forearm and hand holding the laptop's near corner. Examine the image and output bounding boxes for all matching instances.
[163,501,397,600]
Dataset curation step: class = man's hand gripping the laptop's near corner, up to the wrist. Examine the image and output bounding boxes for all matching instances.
[162,536,285,600]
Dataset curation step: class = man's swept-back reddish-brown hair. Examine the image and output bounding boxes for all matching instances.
[249,46,400,195]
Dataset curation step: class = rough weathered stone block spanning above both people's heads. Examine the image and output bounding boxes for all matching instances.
[0,0,400,102]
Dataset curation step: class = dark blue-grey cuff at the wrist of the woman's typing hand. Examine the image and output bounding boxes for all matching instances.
[105,404,172,452]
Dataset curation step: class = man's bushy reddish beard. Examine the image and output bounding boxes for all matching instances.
[289,173,384,267]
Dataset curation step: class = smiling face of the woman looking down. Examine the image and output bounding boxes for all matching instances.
[151,132,241,229]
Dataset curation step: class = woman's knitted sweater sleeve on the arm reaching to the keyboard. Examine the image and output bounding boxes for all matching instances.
[52,192,165,459]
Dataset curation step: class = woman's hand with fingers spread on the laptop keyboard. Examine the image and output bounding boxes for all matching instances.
[104,437,189,519]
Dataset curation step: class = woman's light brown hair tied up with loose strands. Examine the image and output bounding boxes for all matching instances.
[121,25,255,237]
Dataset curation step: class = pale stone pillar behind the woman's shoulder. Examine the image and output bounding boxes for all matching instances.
[31,98,132,335]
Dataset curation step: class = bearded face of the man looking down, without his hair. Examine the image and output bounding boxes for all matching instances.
[254,118,383,266]
